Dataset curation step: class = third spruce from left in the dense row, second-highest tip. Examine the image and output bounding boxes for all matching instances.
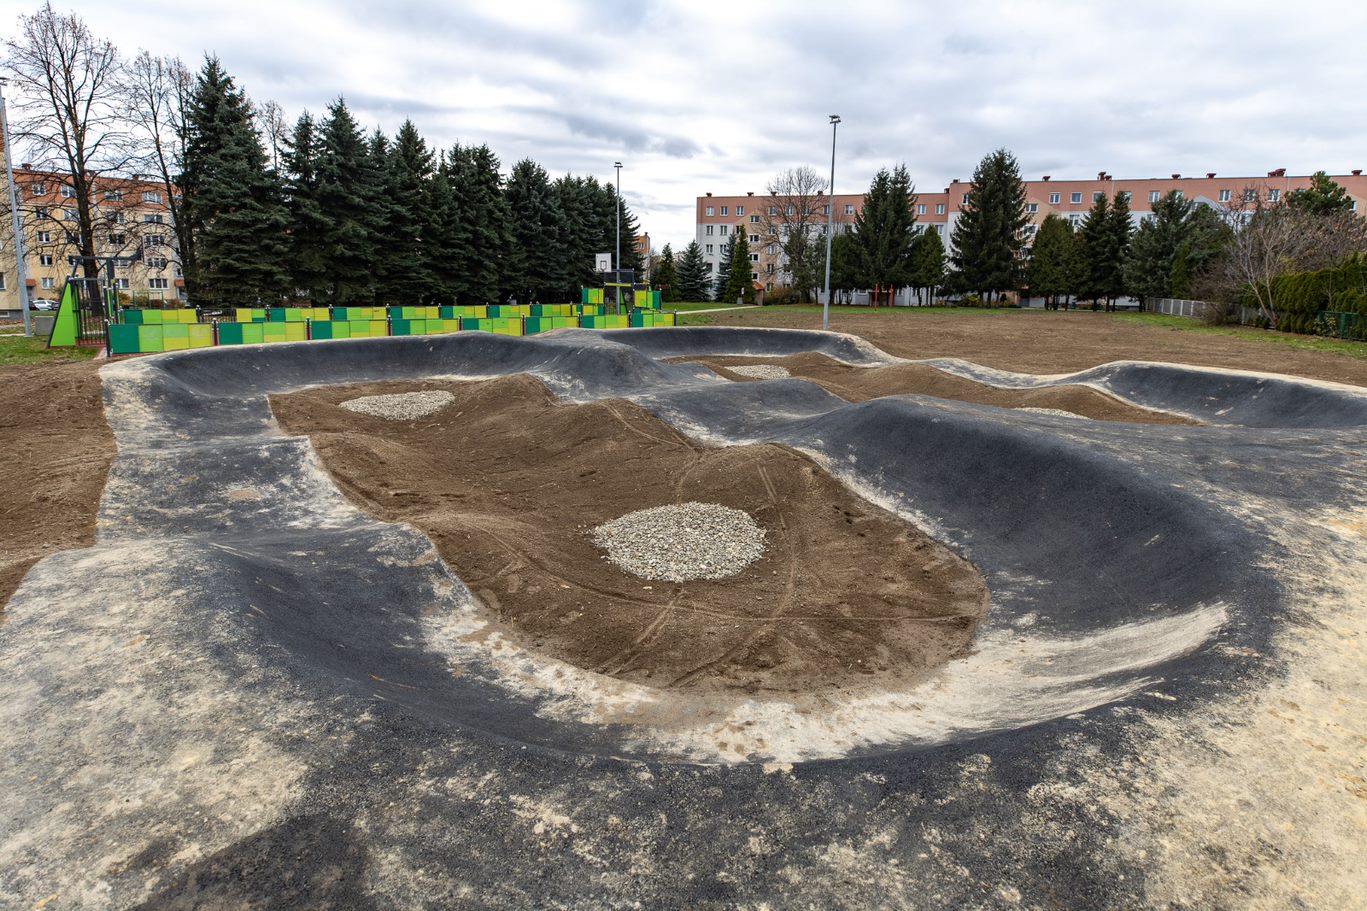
[317,98,380,306]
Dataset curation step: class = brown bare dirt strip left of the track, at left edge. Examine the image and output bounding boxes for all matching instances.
[0,364,115,609]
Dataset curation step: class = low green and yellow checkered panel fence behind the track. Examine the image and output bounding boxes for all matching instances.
[108,304,677,354]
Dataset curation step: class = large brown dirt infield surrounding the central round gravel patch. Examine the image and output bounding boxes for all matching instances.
[272,376,988,694]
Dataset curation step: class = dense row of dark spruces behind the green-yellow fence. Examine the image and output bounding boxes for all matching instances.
[179,57,641,308]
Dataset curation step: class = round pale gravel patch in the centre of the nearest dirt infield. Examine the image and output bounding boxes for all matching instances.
[593,503,764,581]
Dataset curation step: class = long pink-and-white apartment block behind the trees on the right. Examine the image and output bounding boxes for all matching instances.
[696,168,1367,290]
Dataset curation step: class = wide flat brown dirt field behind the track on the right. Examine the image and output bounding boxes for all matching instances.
[694,306,1367,386]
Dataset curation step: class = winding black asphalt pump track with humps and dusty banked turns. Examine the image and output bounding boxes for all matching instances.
[0,328,1367,908]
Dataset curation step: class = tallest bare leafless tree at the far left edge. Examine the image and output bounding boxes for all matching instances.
[5,3,131,278]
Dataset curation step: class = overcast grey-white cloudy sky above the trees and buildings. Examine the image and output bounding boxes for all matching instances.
[32,0,1367,246]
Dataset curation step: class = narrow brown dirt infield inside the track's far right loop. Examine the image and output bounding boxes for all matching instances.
[685,348,1196,424]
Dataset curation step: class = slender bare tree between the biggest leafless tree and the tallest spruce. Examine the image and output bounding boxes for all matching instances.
[126,51,194,274]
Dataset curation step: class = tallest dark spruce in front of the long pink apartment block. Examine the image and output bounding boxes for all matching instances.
[950,149,1029,294]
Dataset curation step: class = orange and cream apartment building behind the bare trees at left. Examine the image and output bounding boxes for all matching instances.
[0,164,185,313]
